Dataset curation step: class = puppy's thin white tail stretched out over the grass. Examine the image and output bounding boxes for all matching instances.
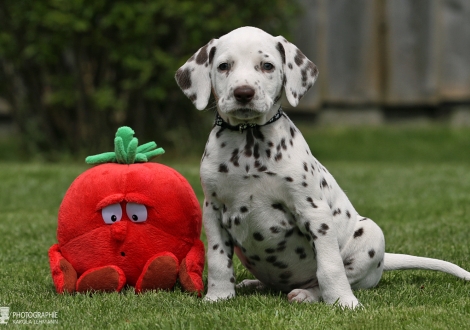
[384,253,470,281]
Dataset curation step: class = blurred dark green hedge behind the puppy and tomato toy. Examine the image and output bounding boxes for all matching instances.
[0,0,299,159]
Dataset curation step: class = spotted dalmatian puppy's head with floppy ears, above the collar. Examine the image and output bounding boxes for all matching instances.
[176,27,318,125]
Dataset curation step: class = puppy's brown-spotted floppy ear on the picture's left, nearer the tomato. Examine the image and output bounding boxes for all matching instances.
[175,39,217,110]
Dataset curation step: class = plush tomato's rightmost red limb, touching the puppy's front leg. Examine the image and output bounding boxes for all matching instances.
[179,241,204,296]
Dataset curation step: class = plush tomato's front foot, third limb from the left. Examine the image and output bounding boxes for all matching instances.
[135,252,178,293]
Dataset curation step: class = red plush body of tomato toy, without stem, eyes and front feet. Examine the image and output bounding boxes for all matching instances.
[49,163,204,292]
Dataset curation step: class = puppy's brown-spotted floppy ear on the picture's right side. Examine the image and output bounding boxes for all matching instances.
[274,36,318,107]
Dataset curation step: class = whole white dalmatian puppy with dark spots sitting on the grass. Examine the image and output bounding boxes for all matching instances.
[176,27,470,308]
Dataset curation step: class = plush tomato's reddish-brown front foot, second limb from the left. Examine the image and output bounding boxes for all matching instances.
[77,265,126,292]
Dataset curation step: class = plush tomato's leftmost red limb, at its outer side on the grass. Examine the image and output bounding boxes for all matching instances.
[48,244,77,293]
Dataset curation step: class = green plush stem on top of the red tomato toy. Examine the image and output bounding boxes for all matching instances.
[85,126,165,165]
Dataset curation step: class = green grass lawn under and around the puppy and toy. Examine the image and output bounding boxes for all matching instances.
[0,125,470,329]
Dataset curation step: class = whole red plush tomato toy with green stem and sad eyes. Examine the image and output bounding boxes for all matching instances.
[49,127,204,295]
